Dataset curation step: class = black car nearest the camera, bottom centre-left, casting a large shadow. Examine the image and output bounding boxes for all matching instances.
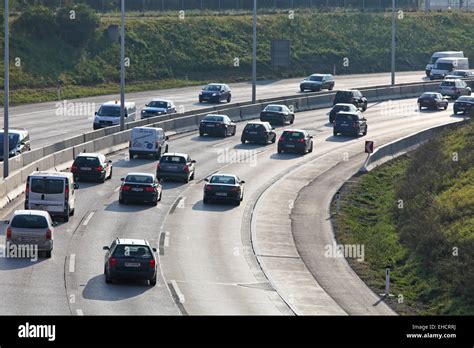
[103,238,158,286]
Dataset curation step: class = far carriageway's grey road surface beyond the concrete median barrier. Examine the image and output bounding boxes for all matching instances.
[0,71,424,148]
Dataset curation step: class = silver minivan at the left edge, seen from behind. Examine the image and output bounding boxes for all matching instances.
[5,210,56,258]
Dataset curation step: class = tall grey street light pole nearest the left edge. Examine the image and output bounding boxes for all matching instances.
[3,0,10,178]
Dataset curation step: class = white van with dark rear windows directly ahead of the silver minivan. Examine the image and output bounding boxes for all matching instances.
[25,171,79,222]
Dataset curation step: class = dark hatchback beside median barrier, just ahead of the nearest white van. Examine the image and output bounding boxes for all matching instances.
[71,153,113,182]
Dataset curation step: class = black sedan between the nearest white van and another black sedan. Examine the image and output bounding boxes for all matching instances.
[119,173,162,205]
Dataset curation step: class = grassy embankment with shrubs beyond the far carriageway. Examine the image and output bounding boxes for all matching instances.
[0,7,474,104]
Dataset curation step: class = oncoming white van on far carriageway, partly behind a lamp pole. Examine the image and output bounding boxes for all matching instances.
[93,100,137,130]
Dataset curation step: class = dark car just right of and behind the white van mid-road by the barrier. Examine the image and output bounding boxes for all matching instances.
[156,153,196,182]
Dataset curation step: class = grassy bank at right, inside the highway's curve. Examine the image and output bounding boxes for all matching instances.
[335,122,474,315]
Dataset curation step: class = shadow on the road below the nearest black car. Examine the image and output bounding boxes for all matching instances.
[82,274,153,301]
